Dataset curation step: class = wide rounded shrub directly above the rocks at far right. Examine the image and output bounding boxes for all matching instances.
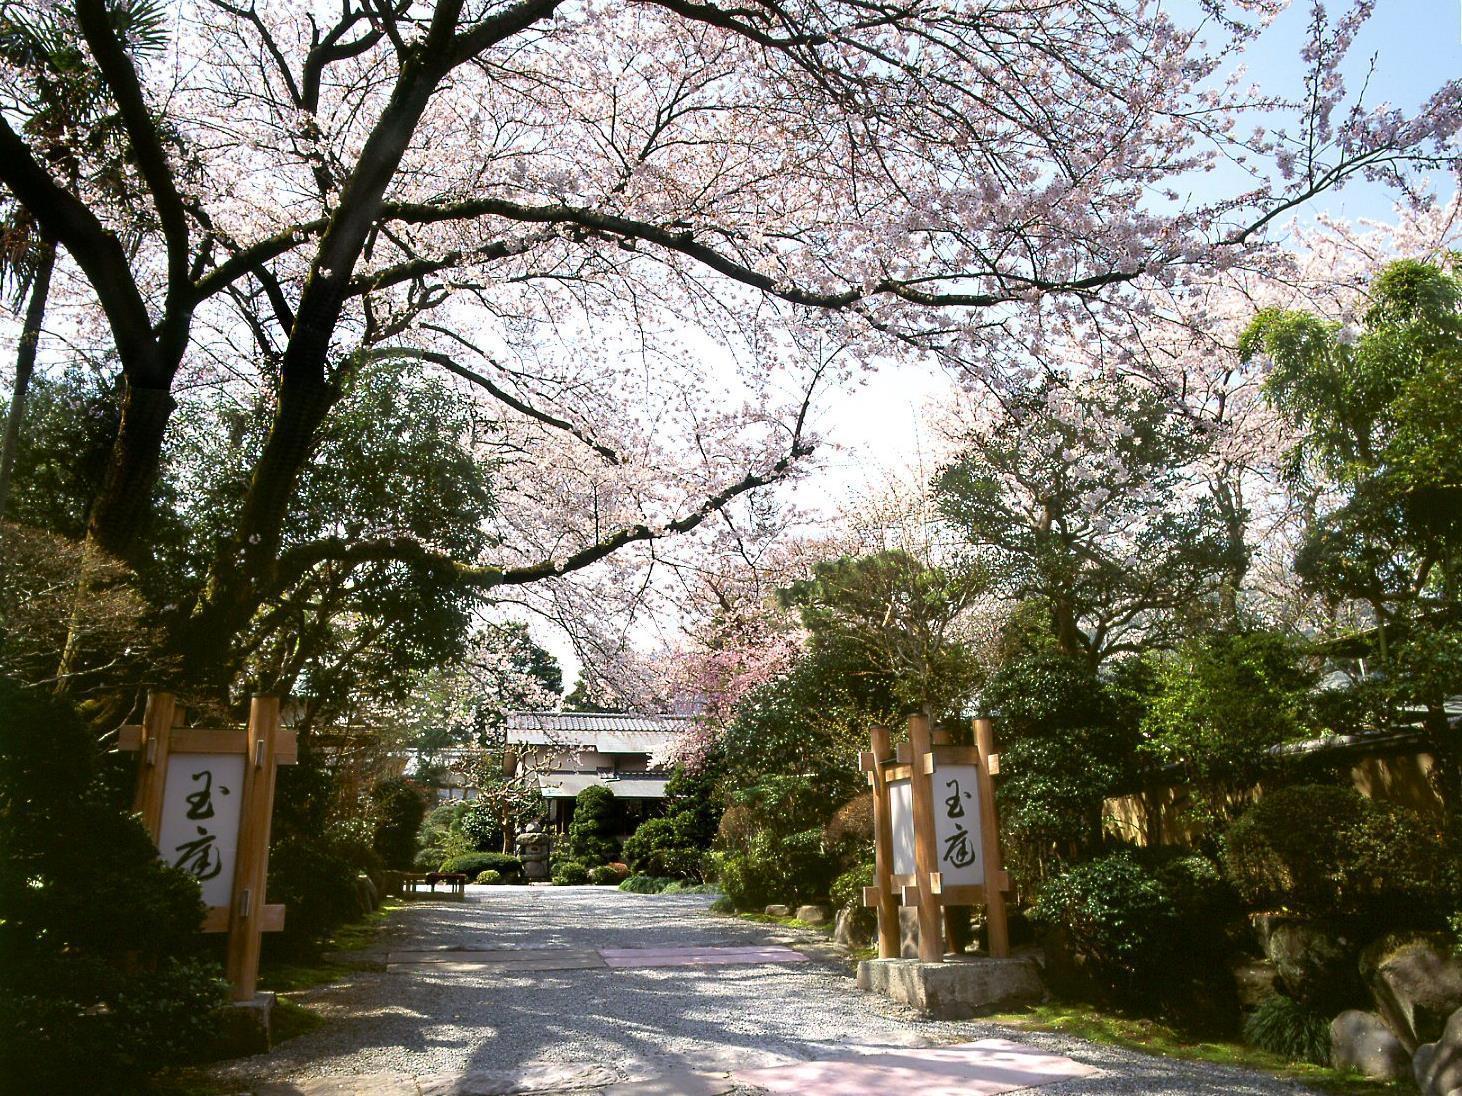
[1224,785,1450,924]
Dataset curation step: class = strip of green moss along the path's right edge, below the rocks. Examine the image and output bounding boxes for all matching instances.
[988,1002,1417,1096]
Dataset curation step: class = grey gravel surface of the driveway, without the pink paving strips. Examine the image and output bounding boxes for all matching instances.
[219,887,1327,1096]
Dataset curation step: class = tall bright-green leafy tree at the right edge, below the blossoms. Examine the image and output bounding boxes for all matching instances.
[1243,260,1462,807]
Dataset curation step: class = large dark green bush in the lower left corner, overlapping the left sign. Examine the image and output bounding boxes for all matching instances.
[0,680,227,1093]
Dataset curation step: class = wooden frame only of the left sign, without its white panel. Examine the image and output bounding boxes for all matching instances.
[117,693,298,1001]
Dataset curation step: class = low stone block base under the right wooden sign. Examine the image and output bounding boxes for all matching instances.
[858,956,1045,1020]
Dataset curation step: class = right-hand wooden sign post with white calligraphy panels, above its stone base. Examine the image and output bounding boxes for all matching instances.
[861,715,1010,963]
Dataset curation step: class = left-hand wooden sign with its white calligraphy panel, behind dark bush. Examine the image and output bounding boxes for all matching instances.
[117,693,297,1001]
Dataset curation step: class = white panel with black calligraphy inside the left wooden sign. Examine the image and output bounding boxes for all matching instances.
[158,754,244,906]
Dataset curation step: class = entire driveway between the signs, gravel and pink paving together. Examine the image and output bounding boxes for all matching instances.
[215,887,1339,1096]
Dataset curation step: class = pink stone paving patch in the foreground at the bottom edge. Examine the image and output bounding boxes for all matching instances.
[732,1039,1098,1096]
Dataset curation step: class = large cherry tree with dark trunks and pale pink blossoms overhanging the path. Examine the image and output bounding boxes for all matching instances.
[0,0,1462,698]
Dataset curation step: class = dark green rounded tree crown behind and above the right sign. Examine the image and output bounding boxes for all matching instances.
[937,381,1234,668]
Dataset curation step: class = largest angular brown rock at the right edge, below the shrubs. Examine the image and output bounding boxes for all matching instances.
[1360,932,1462,1051]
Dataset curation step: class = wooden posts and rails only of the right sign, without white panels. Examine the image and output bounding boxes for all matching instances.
[860,715,1010,963]
